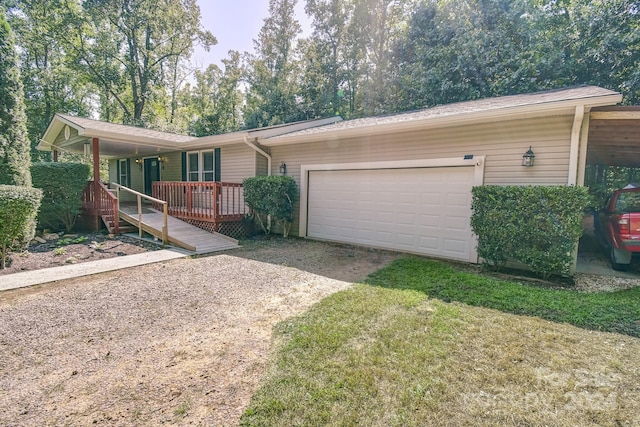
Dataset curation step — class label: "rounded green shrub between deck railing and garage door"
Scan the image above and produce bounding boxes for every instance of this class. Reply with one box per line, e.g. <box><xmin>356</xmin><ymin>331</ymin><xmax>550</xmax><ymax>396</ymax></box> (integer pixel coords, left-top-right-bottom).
<box><xmin>243</xmin><ymin>176</ymin><xmax>298</xmax><ymax>237</ymax></box>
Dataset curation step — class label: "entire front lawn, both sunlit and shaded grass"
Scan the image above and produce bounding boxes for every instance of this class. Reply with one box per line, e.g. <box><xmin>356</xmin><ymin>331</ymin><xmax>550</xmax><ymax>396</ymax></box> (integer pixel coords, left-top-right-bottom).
<box><xmin>241</xmin><ymin>258</ymin><xmax>640</xmax><ymax>426</ymax></box>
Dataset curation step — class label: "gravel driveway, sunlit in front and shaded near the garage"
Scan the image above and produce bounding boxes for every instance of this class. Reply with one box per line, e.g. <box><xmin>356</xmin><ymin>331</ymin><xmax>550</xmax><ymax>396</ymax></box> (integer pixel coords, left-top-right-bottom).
<box><xmin>0</xmin><ymin>239</ymin><xmax>397</xmax><ymax>426</ymax></box>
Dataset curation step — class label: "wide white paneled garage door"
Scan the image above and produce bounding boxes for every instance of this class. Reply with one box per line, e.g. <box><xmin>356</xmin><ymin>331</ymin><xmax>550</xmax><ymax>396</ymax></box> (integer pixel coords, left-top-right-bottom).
<box><xmin>307</xmin><ymin>167</ymin><xmax>475</xmax><ymax>261</ymax></box>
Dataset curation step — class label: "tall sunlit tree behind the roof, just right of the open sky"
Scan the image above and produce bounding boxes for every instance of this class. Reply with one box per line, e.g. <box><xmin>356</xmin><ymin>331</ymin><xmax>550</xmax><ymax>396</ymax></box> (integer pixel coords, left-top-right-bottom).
<box><xmin>244</xmin><ymin>0</ymin><xmax>303</xmax><ymax>128</ymax></box>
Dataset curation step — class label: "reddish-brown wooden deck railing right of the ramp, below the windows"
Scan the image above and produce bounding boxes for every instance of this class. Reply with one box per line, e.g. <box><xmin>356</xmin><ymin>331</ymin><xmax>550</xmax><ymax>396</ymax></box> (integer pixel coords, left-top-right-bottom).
<box><xmin>153</xmin><ymin>181</ymin><xmax>248</xmax><ymax>223</ymax></box>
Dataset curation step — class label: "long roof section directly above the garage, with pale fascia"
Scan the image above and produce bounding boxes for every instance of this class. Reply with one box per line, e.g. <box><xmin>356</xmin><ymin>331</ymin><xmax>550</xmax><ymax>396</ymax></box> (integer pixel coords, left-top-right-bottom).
<box><xmin>260</xmin><ymin>86</ymin><xmax>622</xmax><ymax>146</ymax></box>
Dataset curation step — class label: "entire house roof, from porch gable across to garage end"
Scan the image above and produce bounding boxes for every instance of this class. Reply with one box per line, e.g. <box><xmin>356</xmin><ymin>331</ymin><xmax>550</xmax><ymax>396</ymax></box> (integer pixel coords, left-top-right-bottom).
<box><xmin>38</xmin><ymin>86</ymin><xmax>622</xmax><ymax>158</ymax></box>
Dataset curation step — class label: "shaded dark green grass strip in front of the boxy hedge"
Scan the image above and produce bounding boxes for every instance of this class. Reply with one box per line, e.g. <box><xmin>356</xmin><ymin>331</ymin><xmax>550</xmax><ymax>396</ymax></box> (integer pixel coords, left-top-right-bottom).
<box><xmin>366</xmin><ymin>258</ymin><xmax>640</xmax><ymax>337</ymax></box>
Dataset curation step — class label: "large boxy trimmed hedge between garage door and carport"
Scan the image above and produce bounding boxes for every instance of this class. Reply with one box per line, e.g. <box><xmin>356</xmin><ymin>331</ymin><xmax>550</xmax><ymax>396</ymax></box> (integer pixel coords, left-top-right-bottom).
<box><xmin>471</xmin><ymin>186</ymin><xmax>591</xmax><ymax>276</ymax></box>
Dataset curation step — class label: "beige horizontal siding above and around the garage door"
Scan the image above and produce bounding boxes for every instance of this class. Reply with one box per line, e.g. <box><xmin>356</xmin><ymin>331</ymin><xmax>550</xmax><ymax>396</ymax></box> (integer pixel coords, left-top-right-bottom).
<box><xmin>271</xmin><ymin>116</ymin><xmax>573</xmax><ymax>234</ymax></box>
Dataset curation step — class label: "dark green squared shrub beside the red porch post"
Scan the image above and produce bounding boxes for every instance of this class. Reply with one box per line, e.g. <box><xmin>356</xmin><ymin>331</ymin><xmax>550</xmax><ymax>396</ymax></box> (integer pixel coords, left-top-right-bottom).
<box><xmin>31</xmin><ymin>162</ymin><xmax>89</xmax><ymax>231</ymax></box>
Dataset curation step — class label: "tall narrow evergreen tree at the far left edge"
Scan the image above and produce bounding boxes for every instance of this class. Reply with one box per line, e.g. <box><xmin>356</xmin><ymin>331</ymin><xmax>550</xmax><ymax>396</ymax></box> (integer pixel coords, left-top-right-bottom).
<box><xmin>0</xmin><ymin>10</ymin><xmax>31</xmax><ymax>187</ymax></box>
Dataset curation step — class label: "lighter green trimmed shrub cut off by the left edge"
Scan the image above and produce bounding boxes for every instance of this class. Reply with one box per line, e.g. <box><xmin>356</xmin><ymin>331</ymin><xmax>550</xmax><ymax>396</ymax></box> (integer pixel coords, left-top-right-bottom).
<box><xmin>0</xmin><ymin>185</ymin><xmax>42</xmax><ymax>269</ymax></box>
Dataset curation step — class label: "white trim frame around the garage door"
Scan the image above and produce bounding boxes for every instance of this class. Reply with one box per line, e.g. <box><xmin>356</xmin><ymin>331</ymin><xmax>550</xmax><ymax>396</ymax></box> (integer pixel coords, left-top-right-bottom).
<box><xmin>298</xmin><ymin>156</ymin><xmax>485</xmax><ymax>263</ymax></box>
